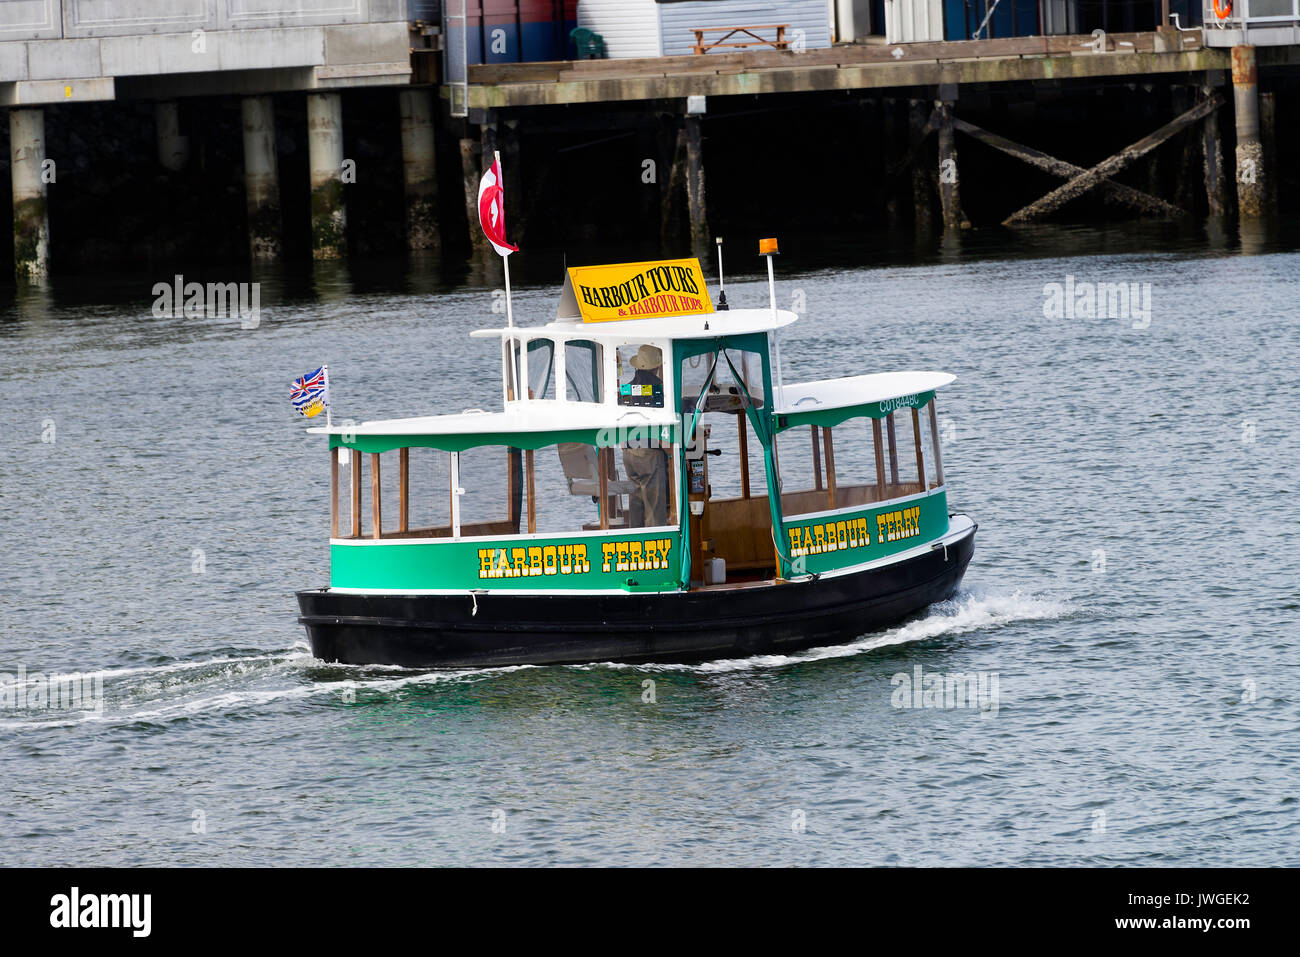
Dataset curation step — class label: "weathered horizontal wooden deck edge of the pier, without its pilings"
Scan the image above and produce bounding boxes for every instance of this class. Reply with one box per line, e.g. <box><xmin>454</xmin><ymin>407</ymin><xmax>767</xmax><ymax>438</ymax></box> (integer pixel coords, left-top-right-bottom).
<box><xmin>457</xmin><ymin>31</ymin><xmax>1230</xmax><ymax>108</ymax></box>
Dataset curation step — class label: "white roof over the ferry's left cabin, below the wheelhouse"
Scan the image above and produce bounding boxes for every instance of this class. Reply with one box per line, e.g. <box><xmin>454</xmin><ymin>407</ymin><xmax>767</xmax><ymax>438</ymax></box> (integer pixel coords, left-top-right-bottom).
<box><xmin>307</xmin><ymin>399</ymin><xmax>677</xmax><ymax>436</ymax></box>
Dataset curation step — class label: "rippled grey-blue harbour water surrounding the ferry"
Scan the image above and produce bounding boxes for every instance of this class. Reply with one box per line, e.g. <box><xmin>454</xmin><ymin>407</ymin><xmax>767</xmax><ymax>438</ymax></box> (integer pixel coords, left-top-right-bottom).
<box><xmin>0</xmin><ymin>230</ymin><xmax>1300</xmax><ymax>865</ymax></box>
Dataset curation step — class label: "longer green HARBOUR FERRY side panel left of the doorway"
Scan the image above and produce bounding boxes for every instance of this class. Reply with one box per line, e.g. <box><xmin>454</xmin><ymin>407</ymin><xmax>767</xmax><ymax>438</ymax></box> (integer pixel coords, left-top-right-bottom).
<box><xmin>330</xmin><ymin>529</ymin><xmax>681</xmax><ymax>592</ymax></box>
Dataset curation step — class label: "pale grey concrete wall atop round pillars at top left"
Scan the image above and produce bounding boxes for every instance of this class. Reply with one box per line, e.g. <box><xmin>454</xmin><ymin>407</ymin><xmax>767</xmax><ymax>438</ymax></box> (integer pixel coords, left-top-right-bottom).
<box><xmin>0</xmin><ymin>0</ymin><xmax>411</xmax><ymax>105</ymax></box>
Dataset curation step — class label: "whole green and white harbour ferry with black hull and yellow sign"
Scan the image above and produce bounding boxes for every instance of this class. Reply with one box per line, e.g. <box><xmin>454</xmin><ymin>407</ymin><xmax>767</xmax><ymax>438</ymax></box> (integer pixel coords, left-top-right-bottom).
<box><xmin>298</xmin><ymin>248</ymin><xmax>976</xmax><ymax>667</ymax></box>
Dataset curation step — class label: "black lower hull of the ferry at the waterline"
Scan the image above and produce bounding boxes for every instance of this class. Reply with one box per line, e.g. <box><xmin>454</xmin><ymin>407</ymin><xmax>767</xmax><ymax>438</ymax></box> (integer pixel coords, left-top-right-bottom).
<box><xmin>298</xmin><ymin>525</ymin><xmax>975</xmax><ymax>668</ymax></box>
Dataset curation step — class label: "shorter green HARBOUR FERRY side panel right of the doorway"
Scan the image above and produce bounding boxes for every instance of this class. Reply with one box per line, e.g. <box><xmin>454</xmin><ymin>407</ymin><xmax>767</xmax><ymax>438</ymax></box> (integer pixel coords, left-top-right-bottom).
<box><xmin>781</xmin><ymin>489</ymin><xmax>948</xmax><ymax>575</ymax></box>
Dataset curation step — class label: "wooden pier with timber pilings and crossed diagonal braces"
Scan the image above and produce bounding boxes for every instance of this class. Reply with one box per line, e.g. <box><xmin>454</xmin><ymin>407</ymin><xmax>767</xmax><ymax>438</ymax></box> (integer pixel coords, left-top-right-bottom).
<box><xmin>443</xmin><ymin>29</ymin><xmax>1300</xmax><ymax>255</ymax></box>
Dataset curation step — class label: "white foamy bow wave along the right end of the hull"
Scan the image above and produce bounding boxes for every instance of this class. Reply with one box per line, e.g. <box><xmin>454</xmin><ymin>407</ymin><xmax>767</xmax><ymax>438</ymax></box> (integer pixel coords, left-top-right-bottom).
<box><xmin>576</xmin><ymin>589</ymin><xmax>1075</xmax><ymax>674</ymax></box>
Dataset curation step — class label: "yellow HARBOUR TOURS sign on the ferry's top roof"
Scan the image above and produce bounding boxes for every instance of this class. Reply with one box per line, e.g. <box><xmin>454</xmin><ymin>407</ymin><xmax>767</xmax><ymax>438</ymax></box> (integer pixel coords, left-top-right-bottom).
<box><xmin>555</xmin><ymin>259</ymin><xmax>714</xmax><ymax>322</ymax></box>
